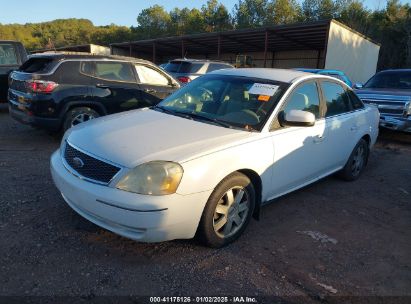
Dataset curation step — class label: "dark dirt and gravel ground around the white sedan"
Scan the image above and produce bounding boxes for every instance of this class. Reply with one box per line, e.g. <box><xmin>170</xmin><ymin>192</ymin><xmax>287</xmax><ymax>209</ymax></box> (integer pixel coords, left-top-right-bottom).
<box><xmin>0</xmin><ymin>105</ymin><xmax>411</xmax><ymax>303</ymax></box>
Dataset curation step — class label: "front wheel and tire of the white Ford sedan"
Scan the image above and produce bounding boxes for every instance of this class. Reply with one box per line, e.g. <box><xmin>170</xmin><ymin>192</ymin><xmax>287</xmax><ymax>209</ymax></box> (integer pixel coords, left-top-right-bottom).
<box><xmin>198</xmin><ymin>173</ymin><xmax>256</xmax><ymax>248</ymax></box>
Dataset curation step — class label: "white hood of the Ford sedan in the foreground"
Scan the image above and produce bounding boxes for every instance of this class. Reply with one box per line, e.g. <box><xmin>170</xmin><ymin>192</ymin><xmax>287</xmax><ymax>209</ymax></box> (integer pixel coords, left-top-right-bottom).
<box><xmin>66</xmin><ymin>109</ymin><xmax>256</xmax><ymax>168</ymax></box>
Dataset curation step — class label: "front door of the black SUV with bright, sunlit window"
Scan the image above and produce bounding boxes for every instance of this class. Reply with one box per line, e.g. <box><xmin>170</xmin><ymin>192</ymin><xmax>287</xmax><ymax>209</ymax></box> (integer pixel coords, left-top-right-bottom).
<box><xmin>134</xmin><ymin>64</ymin><xmax>177</xmax><ymax>106</ymax></box>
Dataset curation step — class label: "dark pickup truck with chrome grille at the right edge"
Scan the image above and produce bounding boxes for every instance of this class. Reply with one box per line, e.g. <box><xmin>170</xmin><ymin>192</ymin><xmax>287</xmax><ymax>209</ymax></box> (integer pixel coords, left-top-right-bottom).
<box><xmin>354</xmin><ymin>69</ymin><xmax>411</xmax><ymax>132</ymax></box>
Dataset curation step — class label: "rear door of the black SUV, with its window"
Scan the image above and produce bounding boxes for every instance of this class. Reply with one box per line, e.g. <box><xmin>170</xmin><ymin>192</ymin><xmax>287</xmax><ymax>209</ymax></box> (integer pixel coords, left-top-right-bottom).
<box><xmin>84</xmin><ymin>60</ymin><xmax>146</xmax><ymax>114</ymax></box>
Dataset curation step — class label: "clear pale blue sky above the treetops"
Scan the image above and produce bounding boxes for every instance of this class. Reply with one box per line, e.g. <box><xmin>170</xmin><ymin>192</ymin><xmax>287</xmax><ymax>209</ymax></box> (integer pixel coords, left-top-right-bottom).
<box><xmin>0</xmin><ymin>0</ymin><xmax>411</xmax><ymax>26</ymax></box>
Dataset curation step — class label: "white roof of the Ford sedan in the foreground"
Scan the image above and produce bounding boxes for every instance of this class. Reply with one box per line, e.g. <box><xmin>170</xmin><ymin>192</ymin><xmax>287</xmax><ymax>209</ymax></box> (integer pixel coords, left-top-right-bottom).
<box><xmin>211</xmin><ymin>68</ymin><xmax>314</xmax><ymax>83</ymax></box>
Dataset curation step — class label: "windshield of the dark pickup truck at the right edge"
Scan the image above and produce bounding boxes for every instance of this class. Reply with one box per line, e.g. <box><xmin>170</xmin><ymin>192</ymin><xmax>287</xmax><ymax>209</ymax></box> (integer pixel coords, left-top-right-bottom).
<box><xmin>364</xmin><ymin>71</ymin><xmax>411</xmax><ymax>90</ymax></box>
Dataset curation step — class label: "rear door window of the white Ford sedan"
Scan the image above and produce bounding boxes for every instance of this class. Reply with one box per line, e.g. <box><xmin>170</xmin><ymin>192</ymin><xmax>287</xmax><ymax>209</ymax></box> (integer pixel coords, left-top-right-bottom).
<box><xmin>321</xmin><ymin>81</ymin><xmax>351</xmax><ymax>117</ymax></box>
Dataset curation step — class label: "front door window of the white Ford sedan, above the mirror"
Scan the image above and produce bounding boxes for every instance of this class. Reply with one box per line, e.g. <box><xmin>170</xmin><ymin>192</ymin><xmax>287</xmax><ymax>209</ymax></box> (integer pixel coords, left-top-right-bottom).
<box><xmin>283</xmin><ymin>82</ymin><xmax>320</xmax><ymax>119</ymax></box>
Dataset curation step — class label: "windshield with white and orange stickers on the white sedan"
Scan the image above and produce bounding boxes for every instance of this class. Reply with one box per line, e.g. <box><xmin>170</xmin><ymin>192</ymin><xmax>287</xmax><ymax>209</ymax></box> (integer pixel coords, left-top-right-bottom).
<box><xmin>158</xmin><ymin>75</ymin><xmax>288</xmax><ymax>130</ymax></box>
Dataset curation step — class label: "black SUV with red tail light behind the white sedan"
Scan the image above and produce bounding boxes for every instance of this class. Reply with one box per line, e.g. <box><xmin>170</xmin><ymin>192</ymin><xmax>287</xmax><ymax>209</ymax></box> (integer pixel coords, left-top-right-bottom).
<box><xmin>8</xmin><ymin>53</ymin><xmax>180</xmax><ymax>131</ymax></box>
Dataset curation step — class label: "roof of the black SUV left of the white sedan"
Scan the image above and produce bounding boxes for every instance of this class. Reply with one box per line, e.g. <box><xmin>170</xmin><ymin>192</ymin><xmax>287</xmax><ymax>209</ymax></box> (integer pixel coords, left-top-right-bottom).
<box><xmin>30</xmin><ymin>51</ymin><xmax>153</xmax><ymax>64</ymax></box>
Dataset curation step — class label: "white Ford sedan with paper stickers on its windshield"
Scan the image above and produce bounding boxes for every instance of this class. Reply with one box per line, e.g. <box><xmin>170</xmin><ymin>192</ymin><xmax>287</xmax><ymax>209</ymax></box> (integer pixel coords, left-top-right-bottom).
<box><xmin>51</xmin><ymin>69</ymin><xmax>379</xmax><ymax>247</ymax></box>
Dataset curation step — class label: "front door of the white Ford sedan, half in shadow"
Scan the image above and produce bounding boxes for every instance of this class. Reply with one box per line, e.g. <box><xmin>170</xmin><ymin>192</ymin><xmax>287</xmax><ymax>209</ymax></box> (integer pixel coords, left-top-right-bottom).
<box><xmin>270</xmin><ymin>81</ymin><xmax>330</xmax><ymax>198</ymax></box>
